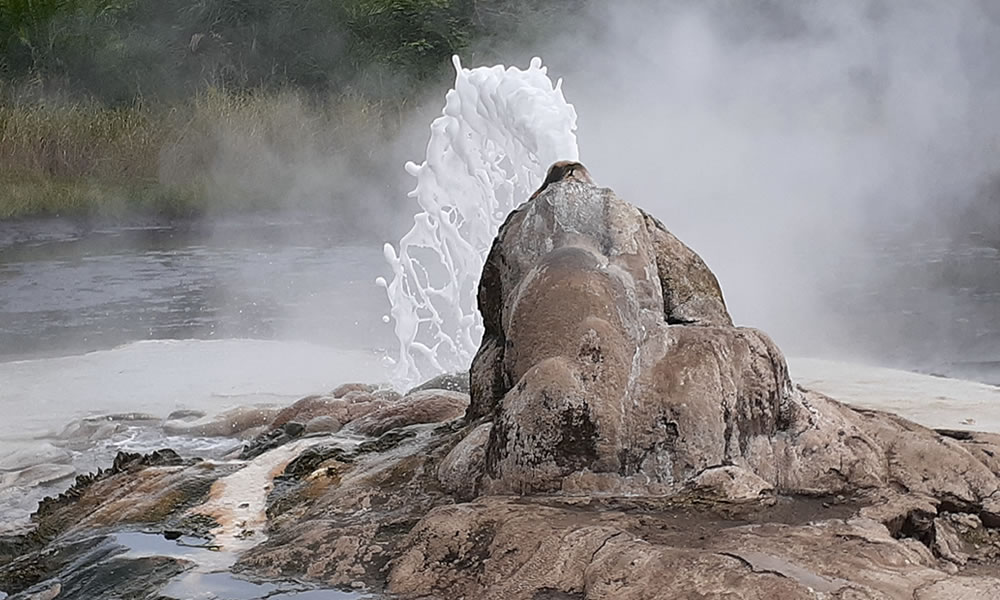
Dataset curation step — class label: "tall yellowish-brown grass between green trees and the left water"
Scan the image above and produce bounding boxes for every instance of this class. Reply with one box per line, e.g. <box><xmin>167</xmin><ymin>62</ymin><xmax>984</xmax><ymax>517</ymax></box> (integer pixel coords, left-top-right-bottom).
<box><xmin>0</xmin><ymin>89</ymin><xmax>402</xmax><ymax>219</ymax></box>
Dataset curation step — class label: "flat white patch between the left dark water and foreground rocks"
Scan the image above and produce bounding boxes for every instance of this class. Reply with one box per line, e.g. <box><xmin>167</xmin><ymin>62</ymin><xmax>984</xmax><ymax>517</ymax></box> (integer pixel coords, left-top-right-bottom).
<box><xmin>0</xmin><ymin>340</ymin><xmax>386</xmax><ymax>440</ymax></box>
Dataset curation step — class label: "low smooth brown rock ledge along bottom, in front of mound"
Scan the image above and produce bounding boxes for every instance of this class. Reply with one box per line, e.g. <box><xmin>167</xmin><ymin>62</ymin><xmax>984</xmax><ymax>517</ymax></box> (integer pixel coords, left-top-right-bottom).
<box><xmin>388</xmin><ymin>498</ymin><xmax>972</xmax><ymax>600</ymax></box>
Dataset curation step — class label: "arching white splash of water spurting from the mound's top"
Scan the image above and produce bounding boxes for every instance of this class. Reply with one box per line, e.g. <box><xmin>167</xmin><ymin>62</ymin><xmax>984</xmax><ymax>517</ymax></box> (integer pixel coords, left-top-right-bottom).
<box><xmin>376</xmin><ymin>56</ymin><xmax>579</xmax><ymax>387</ymax></box>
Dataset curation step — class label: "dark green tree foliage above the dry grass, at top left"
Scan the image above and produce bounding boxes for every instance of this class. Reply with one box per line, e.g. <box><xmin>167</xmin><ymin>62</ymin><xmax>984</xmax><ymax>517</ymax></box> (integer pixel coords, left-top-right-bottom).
<box><xmin>0</xmin><ymin>0</ymin><xmax>571</xmax><ymax>104</ymax></box>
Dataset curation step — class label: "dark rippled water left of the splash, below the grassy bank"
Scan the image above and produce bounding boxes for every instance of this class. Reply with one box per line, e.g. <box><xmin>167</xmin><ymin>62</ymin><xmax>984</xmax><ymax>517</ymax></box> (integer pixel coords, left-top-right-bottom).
<box><xmin>0</xmin><ymin>217</ymin><xmax>392</xmax><ymax>360</ymax></box>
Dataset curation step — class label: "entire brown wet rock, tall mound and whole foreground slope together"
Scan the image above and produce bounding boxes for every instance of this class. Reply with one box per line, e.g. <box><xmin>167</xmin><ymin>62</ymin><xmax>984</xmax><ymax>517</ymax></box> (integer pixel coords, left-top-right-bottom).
<box><xmin>0</xmin><ymin>176</ymin><xmax>1000</xmax><ymax>600</ymax></box>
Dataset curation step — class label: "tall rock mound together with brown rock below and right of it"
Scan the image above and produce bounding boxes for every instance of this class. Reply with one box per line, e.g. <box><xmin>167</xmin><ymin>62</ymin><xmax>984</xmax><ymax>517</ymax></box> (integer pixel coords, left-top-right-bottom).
<box><xmin>412</xmin><ymin>171</ymin><xmax>1000</xmax><ymax>598</ymax></box>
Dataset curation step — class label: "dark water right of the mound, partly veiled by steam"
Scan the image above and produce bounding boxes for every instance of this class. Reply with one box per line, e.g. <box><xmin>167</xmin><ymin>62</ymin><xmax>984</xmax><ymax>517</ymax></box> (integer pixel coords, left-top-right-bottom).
<box><xmin>825</xmin><ymin>235</ymin><xmax>1000</xmax><ymax>385</ymax></box>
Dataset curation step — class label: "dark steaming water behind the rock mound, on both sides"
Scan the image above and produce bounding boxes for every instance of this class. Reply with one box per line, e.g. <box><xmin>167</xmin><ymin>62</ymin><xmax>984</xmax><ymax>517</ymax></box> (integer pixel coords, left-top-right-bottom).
<box><xmin>0</xmin><ymin>216</ymin><xmax>1000</xmax><ymax>383</ymax></box>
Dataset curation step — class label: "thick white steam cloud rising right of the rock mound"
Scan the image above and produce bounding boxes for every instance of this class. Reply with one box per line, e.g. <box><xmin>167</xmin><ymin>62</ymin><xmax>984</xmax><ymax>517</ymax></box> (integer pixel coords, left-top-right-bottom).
<box><xmin>474</xmin><ymin>1</ymin><xmax>1000</xmax><ymax>368</ymax></box>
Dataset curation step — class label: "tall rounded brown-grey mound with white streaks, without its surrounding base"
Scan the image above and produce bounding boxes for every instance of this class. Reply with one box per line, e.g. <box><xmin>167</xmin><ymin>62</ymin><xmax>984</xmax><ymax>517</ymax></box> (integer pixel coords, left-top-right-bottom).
<box><xmin>467</xmin><ymin>181</ymin><xmax>885</xmax><ymax>495</ymax></box>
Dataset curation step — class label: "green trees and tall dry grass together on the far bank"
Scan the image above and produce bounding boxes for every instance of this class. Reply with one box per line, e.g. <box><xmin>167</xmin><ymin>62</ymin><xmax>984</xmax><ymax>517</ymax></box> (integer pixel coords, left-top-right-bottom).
<box><xmin>0</xmin><ymin>0</ymin><xmax>574</xmax><ymax>219</ymax></box>
